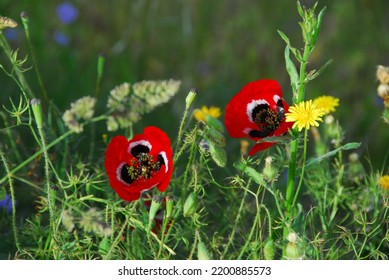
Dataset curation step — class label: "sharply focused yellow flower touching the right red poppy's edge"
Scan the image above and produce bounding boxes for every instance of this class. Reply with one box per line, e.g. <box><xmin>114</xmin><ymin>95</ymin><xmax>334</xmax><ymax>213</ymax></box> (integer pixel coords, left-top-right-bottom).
<box><xmin>285</xmin><ymin>100</ymin><xmax>324</xmax><ymax>131</ymax></box>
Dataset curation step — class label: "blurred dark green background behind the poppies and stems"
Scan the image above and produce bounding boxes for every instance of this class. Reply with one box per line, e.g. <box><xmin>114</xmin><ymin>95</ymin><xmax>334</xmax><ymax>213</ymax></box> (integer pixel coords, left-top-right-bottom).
<box><xmin>0</xmin><ymin>0</ymin><xmax>389</xmax><ymax>169</ymax></box>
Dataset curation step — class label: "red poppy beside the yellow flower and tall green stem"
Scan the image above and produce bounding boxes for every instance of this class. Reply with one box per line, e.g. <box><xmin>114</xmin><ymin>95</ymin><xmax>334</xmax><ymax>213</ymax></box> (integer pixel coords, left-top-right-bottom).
<box><xmin>224</xmin><ymin>80</ymin><xmax>293</xmax><ymax>156</ymax></box>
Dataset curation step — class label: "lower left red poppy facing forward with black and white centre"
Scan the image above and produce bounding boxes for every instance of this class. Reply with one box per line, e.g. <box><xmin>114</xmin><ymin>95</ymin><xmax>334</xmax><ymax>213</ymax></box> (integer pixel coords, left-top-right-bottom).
<box><xmin>104</xmin><ymin>126</ymin><xmax>173</xmax><ymax>201</ymax></box>
